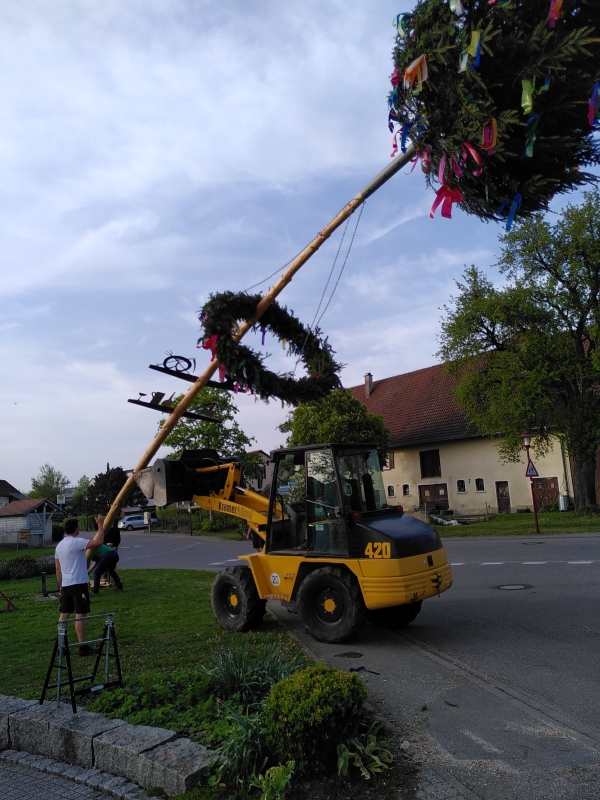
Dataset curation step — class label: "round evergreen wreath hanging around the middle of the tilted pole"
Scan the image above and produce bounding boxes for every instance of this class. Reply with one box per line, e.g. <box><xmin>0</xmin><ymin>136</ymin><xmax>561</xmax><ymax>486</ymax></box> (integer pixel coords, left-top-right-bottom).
<box><xmin>198</xmin><ymin>292</ymin><xmax>342</xmax><ymax>405</ymax></box>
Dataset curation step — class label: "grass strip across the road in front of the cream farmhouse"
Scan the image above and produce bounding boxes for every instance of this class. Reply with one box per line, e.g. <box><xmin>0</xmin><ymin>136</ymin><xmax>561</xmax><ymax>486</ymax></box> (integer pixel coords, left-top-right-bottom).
<box><xmin>434</xmin><ymin>511</ymin><xmax>600</xmax><ymax>538</ymax></box>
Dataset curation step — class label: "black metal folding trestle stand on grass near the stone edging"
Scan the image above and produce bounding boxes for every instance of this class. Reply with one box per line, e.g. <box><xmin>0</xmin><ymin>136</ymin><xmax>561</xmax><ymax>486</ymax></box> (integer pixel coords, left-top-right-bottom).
<box><xmin>40</xmin><ymin>611</ymin><xmax>123</xmax><ymax>714</ymax></box>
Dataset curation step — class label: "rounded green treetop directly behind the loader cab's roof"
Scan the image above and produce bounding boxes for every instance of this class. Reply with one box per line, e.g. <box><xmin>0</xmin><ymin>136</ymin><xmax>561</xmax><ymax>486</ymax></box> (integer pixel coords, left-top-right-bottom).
<box><xmin>279</xmin><ymin>389</ymin><xmax>389</xmax><ymax>463</ymax></box>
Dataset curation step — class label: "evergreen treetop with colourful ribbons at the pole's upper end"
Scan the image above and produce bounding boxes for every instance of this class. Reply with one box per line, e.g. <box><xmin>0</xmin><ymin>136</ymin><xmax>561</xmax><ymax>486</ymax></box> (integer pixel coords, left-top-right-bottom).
<box><xmin>389</xmin><ymin>0</ymin><xmax>600</xmax><ymax>226</ymax></box>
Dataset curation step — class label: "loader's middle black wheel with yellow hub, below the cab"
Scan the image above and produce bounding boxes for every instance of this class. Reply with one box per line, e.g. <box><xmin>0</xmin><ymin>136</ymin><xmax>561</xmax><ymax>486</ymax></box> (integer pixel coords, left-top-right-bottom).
<box><xmin>297</xmin><ymin>567</ymin><xmax>367</xmax><ymax>643</ymax></box>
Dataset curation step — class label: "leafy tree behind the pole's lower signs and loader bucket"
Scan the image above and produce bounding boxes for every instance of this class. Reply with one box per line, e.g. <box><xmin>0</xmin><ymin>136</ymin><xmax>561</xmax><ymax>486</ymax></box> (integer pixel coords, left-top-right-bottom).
<box><xmin>159</xmin><ymin>386</ymin><xmax>258</xmax><ymax>484</ymax></box>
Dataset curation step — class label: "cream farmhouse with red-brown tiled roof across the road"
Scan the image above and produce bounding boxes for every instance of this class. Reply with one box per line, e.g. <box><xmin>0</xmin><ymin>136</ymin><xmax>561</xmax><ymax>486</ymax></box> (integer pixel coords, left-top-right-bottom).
<box><xmin>349</xmin><ymin>364</ymin><xmax>574</xmax><ymax>515</ymax></box>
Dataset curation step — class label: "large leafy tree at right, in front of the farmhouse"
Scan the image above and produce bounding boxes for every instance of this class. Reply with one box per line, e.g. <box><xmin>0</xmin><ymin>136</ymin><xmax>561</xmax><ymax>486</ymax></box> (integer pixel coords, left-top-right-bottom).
<box><xmin>439</xmin><ymin>190</ymin><xmax>600</xmax><ymax>508</ymax></box>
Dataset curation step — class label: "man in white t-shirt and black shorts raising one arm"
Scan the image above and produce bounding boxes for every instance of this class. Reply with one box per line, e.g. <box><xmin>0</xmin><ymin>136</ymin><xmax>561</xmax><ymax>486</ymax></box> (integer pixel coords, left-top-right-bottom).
<box><xmin>55</xmin><ymin>517</ymin><xmax>104</xmax><ymax>656</ymax></box>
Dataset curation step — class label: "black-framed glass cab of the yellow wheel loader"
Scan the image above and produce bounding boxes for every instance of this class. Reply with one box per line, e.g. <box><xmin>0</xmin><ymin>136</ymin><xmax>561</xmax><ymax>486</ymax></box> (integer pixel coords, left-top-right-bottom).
<box><xmin>266</xmin><ymin>444</ymin><xmax>387</xmax><ymax>558</ymax></box>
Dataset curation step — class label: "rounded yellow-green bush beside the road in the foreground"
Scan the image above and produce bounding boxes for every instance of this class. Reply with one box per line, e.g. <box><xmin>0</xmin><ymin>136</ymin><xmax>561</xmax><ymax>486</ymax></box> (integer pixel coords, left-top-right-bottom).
<box><xmin>265</xmin><ymin>664</ymin><xmax>367</xmax><ymax>774</ymax></box>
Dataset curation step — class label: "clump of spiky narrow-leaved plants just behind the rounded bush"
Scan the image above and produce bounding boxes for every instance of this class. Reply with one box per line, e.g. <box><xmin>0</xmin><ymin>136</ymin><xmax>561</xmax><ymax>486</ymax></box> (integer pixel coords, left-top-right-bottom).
<box><xmin>201</xmin><ymin>636</ymin><xmax>307</xmax><ymax>705</ymax></box>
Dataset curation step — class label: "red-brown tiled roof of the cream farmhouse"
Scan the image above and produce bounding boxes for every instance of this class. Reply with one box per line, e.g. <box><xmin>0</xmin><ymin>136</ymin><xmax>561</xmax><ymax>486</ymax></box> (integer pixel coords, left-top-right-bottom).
<box><xmin>349</xmin><ymin>364</ymin><xmax>483</xmax><ymax>447</ymax></box>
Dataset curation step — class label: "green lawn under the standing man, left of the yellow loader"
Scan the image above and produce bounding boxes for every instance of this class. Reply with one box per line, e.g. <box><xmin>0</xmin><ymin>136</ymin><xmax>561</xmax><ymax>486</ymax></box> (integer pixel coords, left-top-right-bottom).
<box><xmin>0</xmin><ymin>569</ymin><xmax>292</xmax><ymax>698</ymax></box>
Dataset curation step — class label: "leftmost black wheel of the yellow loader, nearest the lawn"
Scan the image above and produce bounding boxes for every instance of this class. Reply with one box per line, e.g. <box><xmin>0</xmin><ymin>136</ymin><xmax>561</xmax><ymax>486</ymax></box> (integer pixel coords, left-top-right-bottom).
<box><xmin>210</xmin><ymin>567</ymin><xmax>267</xmax><ymax>631</ymax></box>
